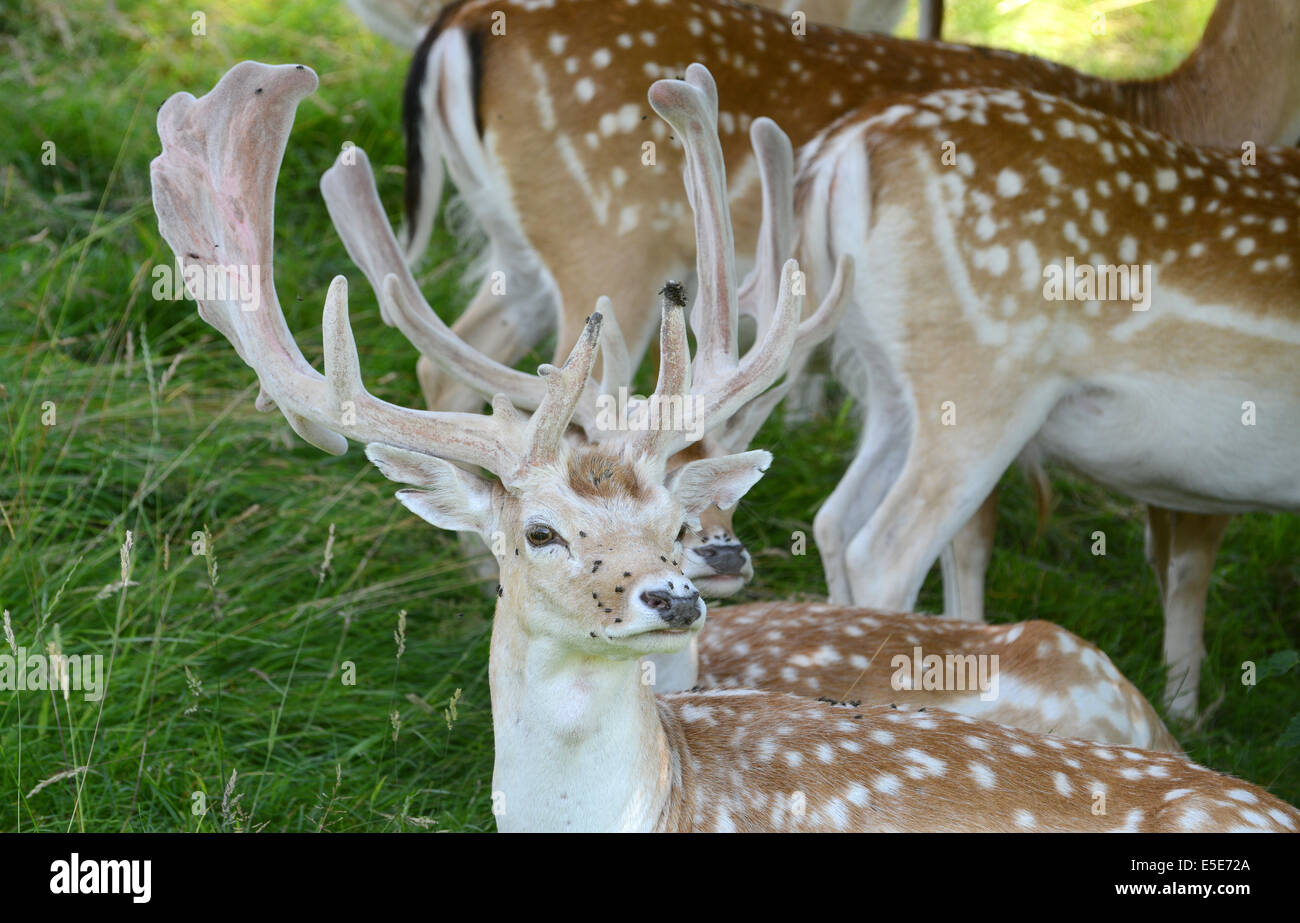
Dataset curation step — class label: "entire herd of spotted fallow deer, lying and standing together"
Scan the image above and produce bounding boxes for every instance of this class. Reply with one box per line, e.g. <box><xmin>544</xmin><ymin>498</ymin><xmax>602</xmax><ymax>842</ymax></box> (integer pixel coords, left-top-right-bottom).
<box><xmin>152</xmin><ymin>0</ymin><xmax>1300</xmax><ymax>831</ymax></box>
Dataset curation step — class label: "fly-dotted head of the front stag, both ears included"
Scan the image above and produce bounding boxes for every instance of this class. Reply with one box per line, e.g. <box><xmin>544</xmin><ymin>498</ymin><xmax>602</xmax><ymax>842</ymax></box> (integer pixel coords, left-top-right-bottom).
<box><xmin>367</xmin><ymin>304</ymin><xmax>771</xmax><ymax>659</ymax></box>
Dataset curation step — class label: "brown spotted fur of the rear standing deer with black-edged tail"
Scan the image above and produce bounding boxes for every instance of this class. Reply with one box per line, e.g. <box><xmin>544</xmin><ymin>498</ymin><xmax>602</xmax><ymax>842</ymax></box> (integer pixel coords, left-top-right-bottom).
<box><xmin>428</xmin><ymin>0</ymin><xmax>1300</xmax><ymax>371</ymax></box>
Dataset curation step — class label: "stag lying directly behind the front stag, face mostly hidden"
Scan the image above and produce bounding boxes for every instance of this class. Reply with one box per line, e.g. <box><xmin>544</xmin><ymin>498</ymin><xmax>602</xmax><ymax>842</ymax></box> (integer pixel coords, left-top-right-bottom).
<box><xmin>321</xmin><ymin>55</ymin><xmax>1178</xmax><ymax>751</ymax></box>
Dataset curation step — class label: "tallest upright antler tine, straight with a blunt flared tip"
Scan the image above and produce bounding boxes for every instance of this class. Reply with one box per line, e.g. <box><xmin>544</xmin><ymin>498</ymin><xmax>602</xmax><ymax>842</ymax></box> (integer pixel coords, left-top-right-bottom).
<box><xmin>649</xmin><ymin>64</ymin><xmax>738</xmax><ymax>380</ymax></box>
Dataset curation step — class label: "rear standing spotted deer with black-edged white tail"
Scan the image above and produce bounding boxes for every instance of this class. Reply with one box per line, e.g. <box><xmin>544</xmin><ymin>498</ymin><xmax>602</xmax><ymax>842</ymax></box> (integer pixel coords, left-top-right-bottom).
<box><xmin>402</xmin><ymin>0</ymin><xmax>1300</xmax><ymax>650</ymax></box>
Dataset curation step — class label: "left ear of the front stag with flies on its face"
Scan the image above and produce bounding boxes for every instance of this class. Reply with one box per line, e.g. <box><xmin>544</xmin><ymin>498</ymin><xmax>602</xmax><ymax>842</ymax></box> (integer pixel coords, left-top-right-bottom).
<box><xmin>365</xmin><ymin>442</ymin><xmax>493</xmax><ymax>536</ymax></box>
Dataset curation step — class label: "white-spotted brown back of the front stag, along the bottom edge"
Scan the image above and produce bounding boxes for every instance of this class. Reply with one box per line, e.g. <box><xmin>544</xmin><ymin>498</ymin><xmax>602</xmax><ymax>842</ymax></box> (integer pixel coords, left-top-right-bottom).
<box><xmin>659</xmin><ymin>693</ymin><xmax>1300</xmax><ymax>832</ymax></box>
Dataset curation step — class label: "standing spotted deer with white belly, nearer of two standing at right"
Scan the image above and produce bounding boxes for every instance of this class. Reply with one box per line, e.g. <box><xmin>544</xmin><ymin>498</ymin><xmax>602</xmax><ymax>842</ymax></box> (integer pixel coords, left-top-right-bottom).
<box><xmin>797</xmin><ymin>90</ymin><xmax>1300</xmax><ymax>715</ymax></box>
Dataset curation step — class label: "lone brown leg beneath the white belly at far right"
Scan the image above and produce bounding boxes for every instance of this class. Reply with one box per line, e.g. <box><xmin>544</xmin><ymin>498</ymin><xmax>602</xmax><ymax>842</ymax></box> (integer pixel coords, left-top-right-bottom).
<box><xmin>1149</xmin><ymin>510</ymin><xmax>1232</xmax><ymax>720</ymax></box>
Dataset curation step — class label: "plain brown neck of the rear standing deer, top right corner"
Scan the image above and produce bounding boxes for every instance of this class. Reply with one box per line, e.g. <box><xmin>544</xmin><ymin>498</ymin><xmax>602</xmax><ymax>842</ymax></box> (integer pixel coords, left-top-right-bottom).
<box><xmin>1122</xmin><ymin>0</ymin><xmax>1300</xmax><ymax>147</ymax></box>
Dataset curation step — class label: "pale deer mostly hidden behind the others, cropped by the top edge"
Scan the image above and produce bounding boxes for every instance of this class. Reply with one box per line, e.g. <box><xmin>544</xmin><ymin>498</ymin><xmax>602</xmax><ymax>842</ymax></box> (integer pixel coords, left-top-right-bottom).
<box><xmin>346</xmin><ymin>0</ymin><xmax>920</xmax><ymax>51</ymax></box>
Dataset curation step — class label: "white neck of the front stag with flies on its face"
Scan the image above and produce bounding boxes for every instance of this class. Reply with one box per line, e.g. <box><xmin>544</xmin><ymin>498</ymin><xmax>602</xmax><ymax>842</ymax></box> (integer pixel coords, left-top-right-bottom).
<box><xmin>489</xmin><ymin>594</ymin><xmax>676</xmax><ymax>832</ymax></box>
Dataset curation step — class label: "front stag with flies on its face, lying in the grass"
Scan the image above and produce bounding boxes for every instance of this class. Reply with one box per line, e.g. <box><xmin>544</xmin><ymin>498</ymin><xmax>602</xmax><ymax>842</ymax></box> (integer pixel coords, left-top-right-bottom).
<box><xmin>151</xmin><ymin>61</ymin><xmax>1300</xmax><ymax>832</ymax></box>
